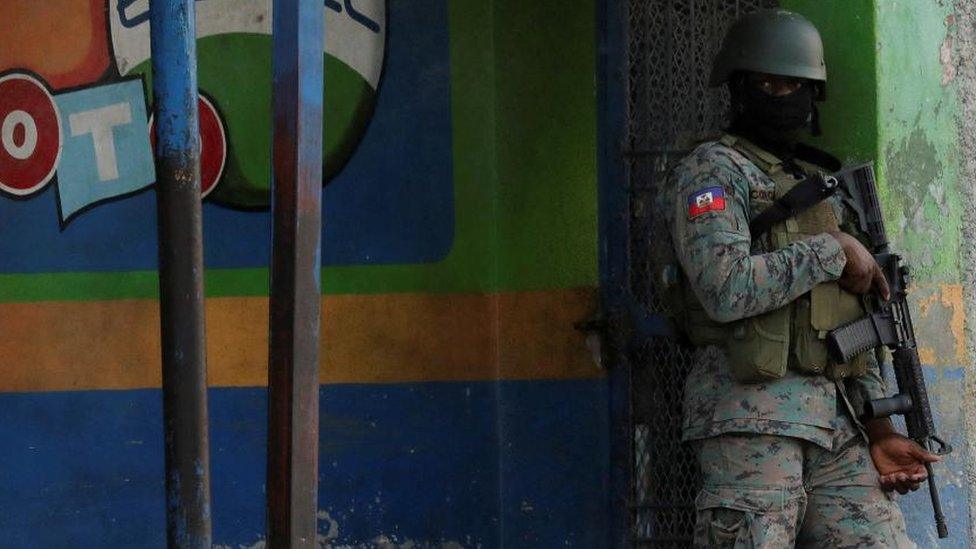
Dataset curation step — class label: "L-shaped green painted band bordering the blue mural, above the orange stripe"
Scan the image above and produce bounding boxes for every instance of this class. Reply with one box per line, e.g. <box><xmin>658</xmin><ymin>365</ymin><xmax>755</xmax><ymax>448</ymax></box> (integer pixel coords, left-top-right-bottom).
<box><xmin>0</xmin><ymin>0</ymin><xmax>597</xmax><ymax>301</ymax></box>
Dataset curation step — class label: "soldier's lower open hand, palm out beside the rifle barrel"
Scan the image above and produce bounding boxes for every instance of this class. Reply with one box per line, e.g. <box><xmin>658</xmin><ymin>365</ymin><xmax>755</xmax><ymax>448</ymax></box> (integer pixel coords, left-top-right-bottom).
<box><xmin>871</xmin><ymin>433</ymin><xmax>940</xmax><ymax>494</ymax></box>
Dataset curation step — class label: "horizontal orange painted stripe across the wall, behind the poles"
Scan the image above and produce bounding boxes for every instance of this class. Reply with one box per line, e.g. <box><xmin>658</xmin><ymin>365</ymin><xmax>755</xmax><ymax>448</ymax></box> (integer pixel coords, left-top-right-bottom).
<box><xmin>0</xmin><ymin>289</ymin><xmax>602</xmax><ymax>392</ymax></box>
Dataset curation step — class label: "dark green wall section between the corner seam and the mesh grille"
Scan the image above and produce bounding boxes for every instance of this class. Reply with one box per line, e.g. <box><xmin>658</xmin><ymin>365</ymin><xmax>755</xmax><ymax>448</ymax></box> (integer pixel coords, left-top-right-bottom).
<box><xmin>494</xmin><ymin>0</ymin><xmax>597</xmax><ymax>290</ymax></box>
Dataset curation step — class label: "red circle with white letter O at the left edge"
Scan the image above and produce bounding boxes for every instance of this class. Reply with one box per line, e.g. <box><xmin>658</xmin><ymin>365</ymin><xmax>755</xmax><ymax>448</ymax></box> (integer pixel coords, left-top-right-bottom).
<box><xmin>0</xmin><ymin>73</ymin><xmax>61</xmax><ymax>196</ymax></box>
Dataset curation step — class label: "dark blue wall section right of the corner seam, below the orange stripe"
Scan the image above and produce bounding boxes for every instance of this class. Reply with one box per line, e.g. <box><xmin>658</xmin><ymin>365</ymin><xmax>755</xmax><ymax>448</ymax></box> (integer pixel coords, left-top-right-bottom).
<box><xmin>498</xmin><ymin>382</ymin><xmax>610</xmax><ymax>548</ymax></box>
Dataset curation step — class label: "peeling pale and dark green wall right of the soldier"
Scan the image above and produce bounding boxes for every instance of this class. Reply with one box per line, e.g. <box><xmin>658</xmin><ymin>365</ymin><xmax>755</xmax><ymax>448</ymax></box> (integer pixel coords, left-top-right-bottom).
<box><xmin>783</xmin><ymin>0</ymin><xmax>976</xmax><ymax>547</ymax></box>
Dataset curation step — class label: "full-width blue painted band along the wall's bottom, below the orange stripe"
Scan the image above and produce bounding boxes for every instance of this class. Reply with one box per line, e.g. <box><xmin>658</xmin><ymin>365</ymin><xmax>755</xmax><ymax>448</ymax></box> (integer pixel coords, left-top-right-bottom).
<box><xmin>0</xmin><ymin>380</ymin><xmax>608</xmax><ymax>547</ymax></box>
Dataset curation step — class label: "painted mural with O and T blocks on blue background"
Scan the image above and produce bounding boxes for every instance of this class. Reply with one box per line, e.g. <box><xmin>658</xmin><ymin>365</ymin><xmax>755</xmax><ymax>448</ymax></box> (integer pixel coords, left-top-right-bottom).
<box><xmin>0</xmin><ymin>0</ymin><xmax>453</xmax><ymax>273</ymax></box>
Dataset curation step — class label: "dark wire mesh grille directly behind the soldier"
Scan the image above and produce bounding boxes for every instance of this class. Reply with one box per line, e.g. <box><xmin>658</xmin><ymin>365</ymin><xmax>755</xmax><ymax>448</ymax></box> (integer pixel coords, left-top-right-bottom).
<box><xmin>626</xmin><ymin>0</ymin><xmax>778</xmax><ymax>547</ymax></box>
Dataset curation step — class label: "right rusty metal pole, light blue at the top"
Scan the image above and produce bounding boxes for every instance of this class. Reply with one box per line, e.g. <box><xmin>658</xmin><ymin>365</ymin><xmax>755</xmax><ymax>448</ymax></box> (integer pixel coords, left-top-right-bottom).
<box><xmin>267</xmin><ymin>0</ymin><xmax>325</xmax><ymax>548</ymax></box>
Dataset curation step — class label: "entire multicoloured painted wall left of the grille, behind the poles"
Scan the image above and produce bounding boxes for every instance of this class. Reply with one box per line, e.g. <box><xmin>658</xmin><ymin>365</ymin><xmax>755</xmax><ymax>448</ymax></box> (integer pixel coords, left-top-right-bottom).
<box><xmin>0</xmin><ymin>0</ymin><xmax>609</xmax><ymax>547</ymax></box>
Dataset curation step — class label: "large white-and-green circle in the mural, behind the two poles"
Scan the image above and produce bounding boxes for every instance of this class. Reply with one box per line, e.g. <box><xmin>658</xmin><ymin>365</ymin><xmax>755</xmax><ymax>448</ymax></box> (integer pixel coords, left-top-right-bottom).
<box><xmin>110</xmin><ymin>0</ymin><xmax>387</xmax><ymax>208</ymax></box>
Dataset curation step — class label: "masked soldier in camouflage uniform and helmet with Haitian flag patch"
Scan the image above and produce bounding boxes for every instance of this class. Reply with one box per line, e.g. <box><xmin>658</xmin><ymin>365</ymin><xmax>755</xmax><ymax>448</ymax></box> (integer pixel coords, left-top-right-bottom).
<box><xmin>664</xmin><ymin>11</ymin><xmax>939</xmax><ymax>547</ymax></box>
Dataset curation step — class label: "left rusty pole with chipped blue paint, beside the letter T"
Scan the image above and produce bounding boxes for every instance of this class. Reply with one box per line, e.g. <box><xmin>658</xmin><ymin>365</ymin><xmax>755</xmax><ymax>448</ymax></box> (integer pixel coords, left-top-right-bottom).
<box><xmin>150</xmin><ymin>0</ymin><xmax>211</xmax><ymax>548</ymax></box>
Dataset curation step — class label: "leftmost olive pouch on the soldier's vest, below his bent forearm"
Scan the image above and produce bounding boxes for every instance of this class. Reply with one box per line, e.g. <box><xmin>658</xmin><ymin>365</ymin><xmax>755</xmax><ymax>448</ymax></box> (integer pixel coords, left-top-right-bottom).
<box><xmin>725</xmin><ymin>305</ymin><xmax>793</xmax><ymax>383</ymax></box>
